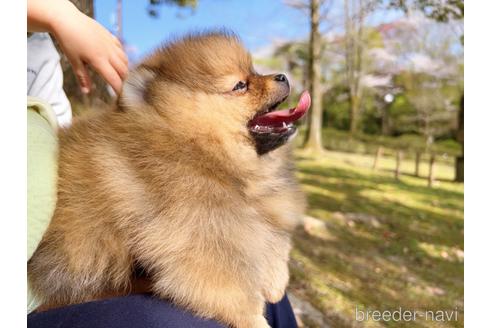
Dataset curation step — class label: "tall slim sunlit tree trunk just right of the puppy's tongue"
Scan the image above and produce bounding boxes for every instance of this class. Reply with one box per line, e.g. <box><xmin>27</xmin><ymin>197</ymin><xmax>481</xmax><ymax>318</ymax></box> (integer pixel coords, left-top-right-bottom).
<box><xmin>304</xmin><ymin>0</ymin><xmax>323</xmax><ymax>152</ymax></box>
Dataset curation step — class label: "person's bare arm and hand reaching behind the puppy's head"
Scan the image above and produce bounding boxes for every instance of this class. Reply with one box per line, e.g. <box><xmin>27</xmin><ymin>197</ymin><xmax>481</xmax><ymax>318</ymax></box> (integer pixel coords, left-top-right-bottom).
<box><xmin>27</xmin><ymin>0</ymin><xmax>128</xmax><ymax>93</ymax></box>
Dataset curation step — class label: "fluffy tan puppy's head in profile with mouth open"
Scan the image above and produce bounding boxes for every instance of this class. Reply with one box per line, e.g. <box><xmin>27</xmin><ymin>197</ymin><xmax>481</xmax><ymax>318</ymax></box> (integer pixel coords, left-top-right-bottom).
<box><xmin>119</xmin><ymin>32</ymin><xmax>311</xmax><ymax>155</ymax></box>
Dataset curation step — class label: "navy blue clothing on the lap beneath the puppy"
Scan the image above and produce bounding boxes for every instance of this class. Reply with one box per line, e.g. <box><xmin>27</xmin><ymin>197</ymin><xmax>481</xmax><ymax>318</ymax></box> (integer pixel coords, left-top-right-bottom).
<box><xmin>27</xmin><ymin>294</ymin><xmax>297</xmax><ymax>328</ymax></box>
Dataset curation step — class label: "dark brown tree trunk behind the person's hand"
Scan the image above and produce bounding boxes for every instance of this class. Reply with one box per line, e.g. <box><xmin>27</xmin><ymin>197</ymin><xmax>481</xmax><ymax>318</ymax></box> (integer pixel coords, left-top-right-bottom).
<box><xmin>52</xmin><ymin>0</ymin><xmax>114</xmax><ymax>110</ymax></box>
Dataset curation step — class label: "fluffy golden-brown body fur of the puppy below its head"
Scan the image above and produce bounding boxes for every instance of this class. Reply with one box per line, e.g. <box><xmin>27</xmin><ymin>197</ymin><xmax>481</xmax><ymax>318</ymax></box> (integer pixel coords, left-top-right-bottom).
<box><xmin>29</xmin><ymin>116</ymin><xmax>304</xmax><ymax>310</ymax></box>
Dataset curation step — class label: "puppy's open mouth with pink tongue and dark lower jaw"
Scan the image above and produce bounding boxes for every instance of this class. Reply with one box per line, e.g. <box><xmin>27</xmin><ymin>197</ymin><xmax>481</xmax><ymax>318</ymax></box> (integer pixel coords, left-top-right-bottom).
<box><xmin>248</xmin><ymin>91</ymin><xmax>311</xmax><ymax>155</ymax></box>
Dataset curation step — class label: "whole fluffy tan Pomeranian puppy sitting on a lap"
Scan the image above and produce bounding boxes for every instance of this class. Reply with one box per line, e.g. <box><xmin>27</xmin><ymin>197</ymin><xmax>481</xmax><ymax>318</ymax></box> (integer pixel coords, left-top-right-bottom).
<box><xmin>28</xmin><ymin>32</ymin><xmax>310</xmax><ymax>328</ymax></box>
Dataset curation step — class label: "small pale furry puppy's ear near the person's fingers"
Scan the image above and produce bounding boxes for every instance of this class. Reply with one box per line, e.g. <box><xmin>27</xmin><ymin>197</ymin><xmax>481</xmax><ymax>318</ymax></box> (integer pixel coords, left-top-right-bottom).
<box><xmin>118</xmin><ymin>67</ymin><xmax>156</xmax><ymax>110</ymax></box>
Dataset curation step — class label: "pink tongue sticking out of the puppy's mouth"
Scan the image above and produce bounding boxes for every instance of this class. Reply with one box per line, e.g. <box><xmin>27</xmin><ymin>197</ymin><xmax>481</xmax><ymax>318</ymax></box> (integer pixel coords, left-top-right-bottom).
<box><xmin>249</xmin><ymin>91</ymin><xmax>311</xmax><ymax>126</ymax></box>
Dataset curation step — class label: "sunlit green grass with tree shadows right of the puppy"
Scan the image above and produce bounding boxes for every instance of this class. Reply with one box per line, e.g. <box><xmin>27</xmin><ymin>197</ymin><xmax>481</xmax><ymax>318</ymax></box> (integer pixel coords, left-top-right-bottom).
<box><xmin>290</xmin><ymin>150</ymin><xmax>464</xmax><ymax>328</ymax></box>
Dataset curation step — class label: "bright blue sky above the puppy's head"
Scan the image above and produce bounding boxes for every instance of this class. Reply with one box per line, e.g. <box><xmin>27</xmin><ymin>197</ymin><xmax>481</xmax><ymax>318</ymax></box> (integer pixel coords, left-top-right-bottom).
<box><xmin>94</xmin><ymin>0</ymin><xmax>402</xmax><ymax>60</ymax></box>
